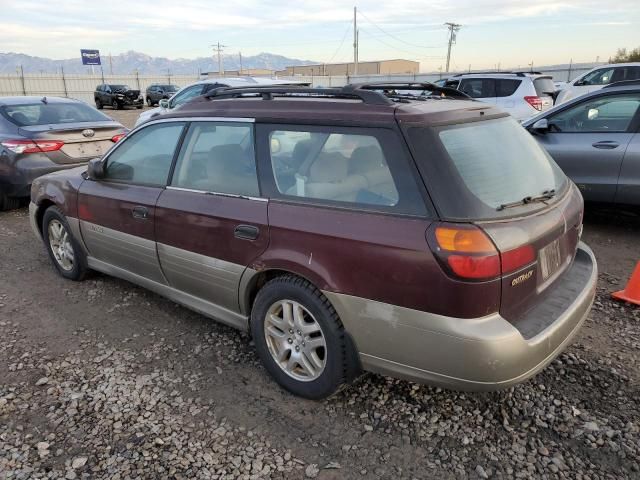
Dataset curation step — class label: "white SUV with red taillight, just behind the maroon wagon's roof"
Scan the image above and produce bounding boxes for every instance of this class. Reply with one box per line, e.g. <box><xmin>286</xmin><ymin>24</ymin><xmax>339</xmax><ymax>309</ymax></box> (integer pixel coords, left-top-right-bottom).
<box><xmin>444</xmin><ymin>72</ymin><xmax>556</xmax><ymax>122</ymax></box>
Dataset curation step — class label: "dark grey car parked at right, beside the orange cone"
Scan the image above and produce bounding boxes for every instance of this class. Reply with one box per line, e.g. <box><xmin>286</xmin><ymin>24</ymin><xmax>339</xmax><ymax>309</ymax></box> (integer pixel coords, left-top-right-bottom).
<box><xmin>523</xmin><ymin>81</ymin><xmax>640</xmax><ymax>207</ymax></box>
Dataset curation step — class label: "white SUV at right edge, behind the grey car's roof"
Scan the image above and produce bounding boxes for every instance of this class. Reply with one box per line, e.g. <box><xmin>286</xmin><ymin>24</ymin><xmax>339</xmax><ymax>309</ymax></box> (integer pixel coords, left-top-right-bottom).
<box><xmin>556</xmin><ymin>62</ymin><xmax>640</xmax><ymax>104</ymax></box>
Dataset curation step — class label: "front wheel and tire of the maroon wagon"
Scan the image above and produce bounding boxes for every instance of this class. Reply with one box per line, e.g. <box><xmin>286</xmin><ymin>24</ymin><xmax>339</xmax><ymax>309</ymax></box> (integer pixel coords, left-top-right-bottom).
<box><xmin>42</xmin><ymin>207</ymin><xmax>88</xmax><ymax>281</ymax></box>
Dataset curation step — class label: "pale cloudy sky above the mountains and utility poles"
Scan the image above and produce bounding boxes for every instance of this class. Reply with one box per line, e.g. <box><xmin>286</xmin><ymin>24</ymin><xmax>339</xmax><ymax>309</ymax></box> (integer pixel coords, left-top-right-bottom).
<box><xmin>0</xmin><ymin>0</ymin><xmax>640</xmax><ymax>71</ymax></box>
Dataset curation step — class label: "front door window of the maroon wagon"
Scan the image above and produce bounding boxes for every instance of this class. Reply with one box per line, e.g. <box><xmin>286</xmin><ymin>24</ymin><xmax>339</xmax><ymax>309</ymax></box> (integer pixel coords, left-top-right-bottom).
<box><xmin>105</xmin><ymin>122</ymin><xmax>185</xmax><ymax>186</ymax></box>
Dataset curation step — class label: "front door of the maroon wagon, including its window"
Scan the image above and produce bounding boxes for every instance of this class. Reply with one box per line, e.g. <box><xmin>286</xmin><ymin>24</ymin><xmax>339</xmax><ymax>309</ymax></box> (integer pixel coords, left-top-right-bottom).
<box><xmin>78</xmin><ymin>122</ymin><xmax>185</xmax><ymax>283</ymax></box>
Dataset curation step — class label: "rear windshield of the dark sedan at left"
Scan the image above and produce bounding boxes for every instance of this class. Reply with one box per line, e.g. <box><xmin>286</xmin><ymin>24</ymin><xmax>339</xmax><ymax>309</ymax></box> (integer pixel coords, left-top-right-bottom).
<box><xmin>0</xmin><ymin>102</ymin><xmax>111</xmax><ymax>127</ymax></box>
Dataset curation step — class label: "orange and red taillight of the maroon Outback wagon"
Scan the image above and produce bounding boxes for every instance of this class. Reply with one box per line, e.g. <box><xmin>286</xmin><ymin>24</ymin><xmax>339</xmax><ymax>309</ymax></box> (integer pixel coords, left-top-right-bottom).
<box><xmin>428</xmin><ymin>224</ymin><xmax>535</xmax><ymax>280</ymax></box>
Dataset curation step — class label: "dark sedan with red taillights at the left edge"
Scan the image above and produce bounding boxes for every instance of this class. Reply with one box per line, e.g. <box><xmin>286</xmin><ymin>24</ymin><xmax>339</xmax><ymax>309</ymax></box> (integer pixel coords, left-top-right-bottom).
<box><xmin>0</xmin><ymin>97</ymin><xmax>127</xmax><ymax>210</ymax></box>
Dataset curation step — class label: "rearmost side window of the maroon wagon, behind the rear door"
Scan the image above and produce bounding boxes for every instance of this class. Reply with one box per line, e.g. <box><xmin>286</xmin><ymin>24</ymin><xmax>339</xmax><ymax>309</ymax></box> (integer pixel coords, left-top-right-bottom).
<box><xmin>270</xmin><ymin>130</ymin><xmax>399</xmax><ymax>206</ymax></box>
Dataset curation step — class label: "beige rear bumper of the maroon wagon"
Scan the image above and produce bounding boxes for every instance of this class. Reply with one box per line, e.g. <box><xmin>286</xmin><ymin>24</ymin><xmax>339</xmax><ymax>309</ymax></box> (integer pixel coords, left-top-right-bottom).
<box><xmin>325</xmin><ymin>243</ymin><xmax>597</xmax><ymax>391</ymax></box>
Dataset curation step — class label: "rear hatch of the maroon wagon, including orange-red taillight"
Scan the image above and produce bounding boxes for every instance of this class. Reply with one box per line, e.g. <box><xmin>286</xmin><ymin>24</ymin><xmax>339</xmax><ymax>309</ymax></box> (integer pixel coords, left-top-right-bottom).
<box><xmin>408</xmin><ymin>117</ymin><xmax>583</xmax><ymax>321</ymax></box>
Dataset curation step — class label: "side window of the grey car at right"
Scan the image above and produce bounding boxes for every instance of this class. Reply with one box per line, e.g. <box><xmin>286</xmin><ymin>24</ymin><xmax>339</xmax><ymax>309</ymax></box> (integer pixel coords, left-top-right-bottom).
<box><xmin>548</xmin><ymin>94</ymin><xmax>640</xmax><ymax>132</ymax></box>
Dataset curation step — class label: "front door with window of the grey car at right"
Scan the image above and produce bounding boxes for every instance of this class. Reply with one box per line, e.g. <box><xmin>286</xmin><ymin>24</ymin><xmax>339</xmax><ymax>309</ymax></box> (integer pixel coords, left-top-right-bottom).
<box><xmin>537</xmin><ymin>92</ymin><xmax>640</xmax><ymax>202</ymax></box>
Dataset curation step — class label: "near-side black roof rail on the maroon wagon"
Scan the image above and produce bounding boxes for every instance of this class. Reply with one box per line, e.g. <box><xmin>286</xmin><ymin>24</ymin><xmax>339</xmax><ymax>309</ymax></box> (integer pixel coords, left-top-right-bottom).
<box><xmin>204</xmin><ymin>85</ymin><xmax>393</xmax><ymax>105</ymax></box>
